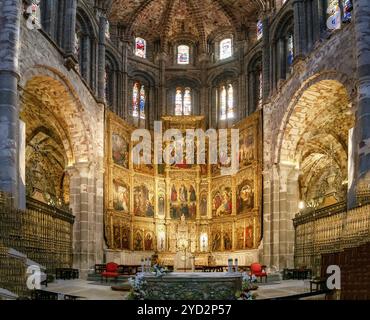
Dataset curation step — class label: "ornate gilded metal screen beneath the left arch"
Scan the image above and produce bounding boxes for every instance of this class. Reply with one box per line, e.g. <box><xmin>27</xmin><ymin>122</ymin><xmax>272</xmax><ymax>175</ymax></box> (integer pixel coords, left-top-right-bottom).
<box><xmin>0</xmin><ymin>194</ymin><xmax>74</xmax><ymax>295</ymax></box>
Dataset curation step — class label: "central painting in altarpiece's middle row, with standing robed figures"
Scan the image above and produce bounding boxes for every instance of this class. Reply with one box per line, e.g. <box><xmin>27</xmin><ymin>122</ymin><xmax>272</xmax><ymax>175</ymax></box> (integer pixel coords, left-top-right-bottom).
<box><xmin>170</xmin><ymin>183</ymin><xmax>197</xmax><ymax>220</ymax></box>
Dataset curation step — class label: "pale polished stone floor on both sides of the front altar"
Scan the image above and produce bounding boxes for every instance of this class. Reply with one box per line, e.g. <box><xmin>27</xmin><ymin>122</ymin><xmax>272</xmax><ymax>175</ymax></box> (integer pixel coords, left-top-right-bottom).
<box><xmin>46</xmin><ymin>280</ymin><xmax>324</xmax><ymax>300</ymax></box>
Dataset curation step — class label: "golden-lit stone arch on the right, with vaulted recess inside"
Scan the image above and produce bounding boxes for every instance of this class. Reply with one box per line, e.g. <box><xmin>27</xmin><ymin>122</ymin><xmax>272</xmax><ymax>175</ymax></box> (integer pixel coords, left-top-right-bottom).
<box><xmin>276</xmin><ymin>76</ymin><xmax>354</xmax><ymax>208</ymax></box>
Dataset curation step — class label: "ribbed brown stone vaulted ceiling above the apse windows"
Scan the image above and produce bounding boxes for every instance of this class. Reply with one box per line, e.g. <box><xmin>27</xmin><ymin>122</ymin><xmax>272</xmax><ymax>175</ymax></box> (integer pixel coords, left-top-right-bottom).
<box><xmin>109</xmin><ymin>0</ymin><xmax>269</xmax><ymax>43</ymax></box>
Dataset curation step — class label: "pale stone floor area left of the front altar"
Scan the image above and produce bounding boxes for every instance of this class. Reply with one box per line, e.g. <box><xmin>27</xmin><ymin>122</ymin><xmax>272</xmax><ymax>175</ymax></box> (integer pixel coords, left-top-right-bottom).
<box><xmin>45</xmin><ymin>279</ymin><xmax>128</xmax><ymax>300</ymax></box>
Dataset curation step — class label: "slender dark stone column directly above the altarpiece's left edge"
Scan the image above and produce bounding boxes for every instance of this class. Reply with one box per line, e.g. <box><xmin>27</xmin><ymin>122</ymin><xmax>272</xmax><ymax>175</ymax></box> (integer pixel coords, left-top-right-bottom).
<box><xmin>98</xmin><ymin>14</ymin><xmax>107</xmax><ymax>103</ymax></box>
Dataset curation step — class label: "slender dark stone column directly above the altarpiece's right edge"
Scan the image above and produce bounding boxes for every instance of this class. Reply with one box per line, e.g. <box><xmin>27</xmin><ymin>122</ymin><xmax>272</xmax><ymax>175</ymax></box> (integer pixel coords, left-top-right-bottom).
<box><xmin>262</xmin><ymin>18</ymin><xmax>270</xmax><ymax>102</ymax></box>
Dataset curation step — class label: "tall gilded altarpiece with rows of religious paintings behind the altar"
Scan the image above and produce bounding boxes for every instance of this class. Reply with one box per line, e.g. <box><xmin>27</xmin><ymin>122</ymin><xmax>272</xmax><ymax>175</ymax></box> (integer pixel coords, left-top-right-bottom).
<box><xmin>105</xmin><ymin>113</ymin><xmax>262</xmax><ymax>268</ymax></box>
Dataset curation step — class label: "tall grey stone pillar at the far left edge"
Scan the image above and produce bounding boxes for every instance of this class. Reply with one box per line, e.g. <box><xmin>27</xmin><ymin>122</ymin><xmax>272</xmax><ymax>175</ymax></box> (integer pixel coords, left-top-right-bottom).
<box><xmin>0</xmin><ymin>0</ymin><xmax>21</xmax><ymax>203</ymax></box>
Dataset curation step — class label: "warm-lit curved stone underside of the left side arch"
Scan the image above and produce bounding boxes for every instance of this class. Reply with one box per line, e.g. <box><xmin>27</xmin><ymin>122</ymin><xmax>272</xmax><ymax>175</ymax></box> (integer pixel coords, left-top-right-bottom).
<box><xmin>19</xmin><ymin>65</ymin><xmax>94</xmax><ymax>165</ymax></box>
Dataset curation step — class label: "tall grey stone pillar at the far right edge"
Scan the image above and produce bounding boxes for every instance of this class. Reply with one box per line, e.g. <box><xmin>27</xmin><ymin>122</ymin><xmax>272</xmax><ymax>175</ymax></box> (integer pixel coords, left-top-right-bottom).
<box><xmin>353</xmin><ymin>0</ymin><xmax>370</xmax><ymax>196</ymax></box>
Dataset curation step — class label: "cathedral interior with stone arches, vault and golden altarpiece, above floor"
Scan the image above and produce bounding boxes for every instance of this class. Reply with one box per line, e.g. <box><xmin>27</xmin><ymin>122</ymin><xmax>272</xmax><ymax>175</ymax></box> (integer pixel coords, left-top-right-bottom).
<box><xmin>0</xmin><ymin>0</ymin><xmax>370</xmax><ymax>300</ymax></box>
